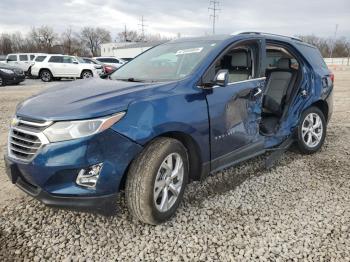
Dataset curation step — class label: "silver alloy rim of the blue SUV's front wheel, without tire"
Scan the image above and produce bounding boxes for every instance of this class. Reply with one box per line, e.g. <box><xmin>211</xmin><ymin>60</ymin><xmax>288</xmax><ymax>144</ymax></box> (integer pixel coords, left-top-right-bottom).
<box><xmin>153</xmin><ymin>153</ymin><xmax>184</xmax><ymax>212</ymax></box>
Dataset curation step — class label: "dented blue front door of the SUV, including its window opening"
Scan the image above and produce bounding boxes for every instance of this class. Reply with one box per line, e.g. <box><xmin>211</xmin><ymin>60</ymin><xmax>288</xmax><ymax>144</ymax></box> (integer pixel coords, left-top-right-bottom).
<box><xmin>207</xmin><ymin>40</ymin><xmax>265</xmax><ymax>170</ymax></box>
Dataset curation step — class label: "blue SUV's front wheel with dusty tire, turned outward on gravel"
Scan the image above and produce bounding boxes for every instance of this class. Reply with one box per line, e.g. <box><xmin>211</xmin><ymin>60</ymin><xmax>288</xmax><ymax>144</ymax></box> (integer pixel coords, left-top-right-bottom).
<box><xmin>125</xmin><ymin>138</ymin><xmax>189</xmax><ymax>225</ymax></box>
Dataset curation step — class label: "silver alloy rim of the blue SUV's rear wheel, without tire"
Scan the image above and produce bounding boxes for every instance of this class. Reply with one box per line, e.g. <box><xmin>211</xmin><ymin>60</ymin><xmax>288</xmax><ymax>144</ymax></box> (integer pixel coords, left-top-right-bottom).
<box><xmin>301</xmin><ymin>113</ymin><xmax>323</xmax><ymax>148</ymax></box>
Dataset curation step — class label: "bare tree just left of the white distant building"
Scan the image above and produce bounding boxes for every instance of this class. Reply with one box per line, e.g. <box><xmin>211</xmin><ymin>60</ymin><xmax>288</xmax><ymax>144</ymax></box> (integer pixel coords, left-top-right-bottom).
<box><xmin>80</xmin><ymin>27</ymin><xmax>111</xmax><ymax>56</ymax></box>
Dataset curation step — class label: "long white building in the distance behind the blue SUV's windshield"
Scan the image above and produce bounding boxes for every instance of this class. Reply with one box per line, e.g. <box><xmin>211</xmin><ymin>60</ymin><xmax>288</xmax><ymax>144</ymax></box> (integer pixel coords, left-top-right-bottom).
<box><xmin>101</xmin><ymin>41</ymin><xmax>167</xmax><ymax>58</ymax></box>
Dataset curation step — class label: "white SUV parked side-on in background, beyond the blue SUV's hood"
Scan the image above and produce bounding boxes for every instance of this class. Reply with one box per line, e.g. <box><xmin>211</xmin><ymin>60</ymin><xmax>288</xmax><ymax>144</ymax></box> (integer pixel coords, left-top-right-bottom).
<box><xmin>31</xmin><ymin>55</ymin><xmax>99</xmax><ymax>82</ymax></box>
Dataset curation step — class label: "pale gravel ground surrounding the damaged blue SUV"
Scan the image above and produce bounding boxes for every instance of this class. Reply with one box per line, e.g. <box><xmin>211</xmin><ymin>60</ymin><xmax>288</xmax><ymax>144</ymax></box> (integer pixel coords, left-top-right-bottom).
<box><xmin>0</xmin><ymin>71</ymin><xmax>350</xmax><ymax>261</ymax></box>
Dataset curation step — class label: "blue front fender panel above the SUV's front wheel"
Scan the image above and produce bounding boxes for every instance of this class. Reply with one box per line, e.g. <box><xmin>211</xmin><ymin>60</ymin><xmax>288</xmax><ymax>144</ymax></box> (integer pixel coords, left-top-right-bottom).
<box><xmin>112</xmin><ymin>90</ymin><xmax>210</xmax><ymax>161</ymax></box>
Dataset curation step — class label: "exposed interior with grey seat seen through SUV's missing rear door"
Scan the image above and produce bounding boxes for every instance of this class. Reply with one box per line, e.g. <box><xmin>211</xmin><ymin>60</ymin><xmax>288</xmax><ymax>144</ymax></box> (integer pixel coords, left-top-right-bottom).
<box><xmin>260</xmin><ymin>45</ymin><xmax>301</xmax><ymax>134</ymax></box>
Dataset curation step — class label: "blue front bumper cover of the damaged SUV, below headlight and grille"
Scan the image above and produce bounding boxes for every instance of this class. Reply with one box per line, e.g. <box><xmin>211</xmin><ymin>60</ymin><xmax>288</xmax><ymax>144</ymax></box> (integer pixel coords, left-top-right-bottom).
<box><xmin>5</xmin><ymin>129</ymin><xmax>142</xmax><ymax>212</ymax></box>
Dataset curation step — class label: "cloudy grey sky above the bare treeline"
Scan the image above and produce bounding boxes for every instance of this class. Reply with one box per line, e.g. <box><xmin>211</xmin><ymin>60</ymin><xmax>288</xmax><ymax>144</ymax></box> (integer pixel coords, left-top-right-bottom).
<box><xmin>0</xmin><ymin>0</ymin><xmax>350</xmax><ymax>40</ymax></box>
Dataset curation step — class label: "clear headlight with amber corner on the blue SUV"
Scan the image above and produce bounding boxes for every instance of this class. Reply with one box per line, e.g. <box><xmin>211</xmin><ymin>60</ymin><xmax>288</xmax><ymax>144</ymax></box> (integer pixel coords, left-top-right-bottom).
<box><xmin>43</xmin><ymin>112</ymin><xmax>125</xmax><ymax>142</ymax></box>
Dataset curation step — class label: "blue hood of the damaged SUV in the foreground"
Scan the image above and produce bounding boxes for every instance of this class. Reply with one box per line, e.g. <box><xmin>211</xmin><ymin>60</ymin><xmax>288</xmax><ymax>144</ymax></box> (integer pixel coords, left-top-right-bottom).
<box><xmin>16</xmin><ymin>78</ymin><xmax>176</xmax><ymax>121</ymax></box>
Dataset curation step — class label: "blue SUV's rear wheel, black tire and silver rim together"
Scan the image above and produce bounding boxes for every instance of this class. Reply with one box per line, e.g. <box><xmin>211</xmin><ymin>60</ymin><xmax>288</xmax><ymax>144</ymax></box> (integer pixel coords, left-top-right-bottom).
<box><xmin>297</xmin><ymin>107</ymin><xmax>327</xmax><ymax>154</ymax></box>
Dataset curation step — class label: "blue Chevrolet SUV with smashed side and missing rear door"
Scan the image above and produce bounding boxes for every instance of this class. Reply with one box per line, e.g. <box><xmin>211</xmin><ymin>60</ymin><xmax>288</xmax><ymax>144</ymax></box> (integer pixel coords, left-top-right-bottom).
<box><xmin>5</xmin><ymin>32</ymin><xmax>334</xmax><ymax>224</ymax></box>
